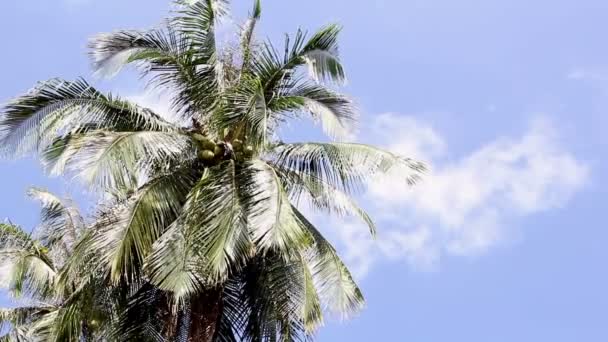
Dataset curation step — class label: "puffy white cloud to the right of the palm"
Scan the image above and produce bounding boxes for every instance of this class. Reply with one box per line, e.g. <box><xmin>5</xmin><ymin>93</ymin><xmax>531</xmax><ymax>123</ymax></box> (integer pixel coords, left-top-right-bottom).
<box><xmin>330</xmin><ymin>114</ymin><xmax>589</xmax><ymax>276</ymax></box>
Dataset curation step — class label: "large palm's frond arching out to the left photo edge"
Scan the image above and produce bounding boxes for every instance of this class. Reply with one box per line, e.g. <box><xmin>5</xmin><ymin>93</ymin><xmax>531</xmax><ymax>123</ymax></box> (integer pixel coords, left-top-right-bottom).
<box><xmin>0</xmin><ymin>79</ymin><xmax>174</xmax><ymax>157</ymax></box>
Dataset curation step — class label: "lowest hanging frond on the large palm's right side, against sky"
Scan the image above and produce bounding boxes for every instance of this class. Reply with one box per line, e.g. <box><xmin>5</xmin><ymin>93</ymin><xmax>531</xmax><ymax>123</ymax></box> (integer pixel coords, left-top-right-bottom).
<box><xmin>294</xmin><ymin>208</ymin><xmax>365</xmax><ymax>317</ymax></box>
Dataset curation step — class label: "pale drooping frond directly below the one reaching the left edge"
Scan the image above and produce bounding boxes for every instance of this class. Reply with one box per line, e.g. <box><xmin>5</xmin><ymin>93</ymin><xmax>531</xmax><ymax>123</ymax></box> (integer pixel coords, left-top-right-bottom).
<box><xmin>50</xmin><ymin>131</ymin><xmax>196</xmax><ymax>191</ymax></box>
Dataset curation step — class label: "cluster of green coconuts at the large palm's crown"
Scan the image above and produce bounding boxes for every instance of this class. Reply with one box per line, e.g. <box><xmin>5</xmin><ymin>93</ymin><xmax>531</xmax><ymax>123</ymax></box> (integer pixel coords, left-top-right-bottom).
<box><xmin>192</xmin><ymin>133</ymin><xmax>253</xmax><ymax>166</ymax></box>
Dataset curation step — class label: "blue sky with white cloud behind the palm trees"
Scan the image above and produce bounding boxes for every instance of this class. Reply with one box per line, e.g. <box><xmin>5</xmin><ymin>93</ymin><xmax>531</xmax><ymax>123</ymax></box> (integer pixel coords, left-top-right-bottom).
<box><xmin>0</xmin><ymin>0</ymin><xmax>608</xmax><ymax>342</ymax></box>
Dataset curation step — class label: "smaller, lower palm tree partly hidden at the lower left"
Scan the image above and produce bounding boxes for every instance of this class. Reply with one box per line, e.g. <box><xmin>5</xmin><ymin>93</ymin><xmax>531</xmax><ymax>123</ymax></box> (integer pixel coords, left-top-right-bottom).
<box><xmin>0</xmin><ymin>188</ymin><xmax>192</xmax><ymax>342</ymax></box>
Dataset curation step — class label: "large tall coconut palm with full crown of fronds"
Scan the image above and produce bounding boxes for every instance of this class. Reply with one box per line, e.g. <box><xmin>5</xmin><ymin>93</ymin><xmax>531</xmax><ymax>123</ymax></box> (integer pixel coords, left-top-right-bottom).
<box><xmin>0</xmin><ymin>0</ymin><xmax>424</xmax><ymax>341</ymax></box>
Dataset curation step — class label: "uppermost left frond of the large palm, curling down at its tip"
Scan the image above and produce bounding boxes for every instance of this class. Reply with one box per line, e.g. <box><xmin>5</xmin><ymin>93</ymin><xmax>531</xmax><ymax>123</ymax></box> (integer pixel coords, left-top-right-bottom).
<box><xmin>89</xmin><ymin>26</ymin><xmax>217</xmax><ymax>119</ymax></box>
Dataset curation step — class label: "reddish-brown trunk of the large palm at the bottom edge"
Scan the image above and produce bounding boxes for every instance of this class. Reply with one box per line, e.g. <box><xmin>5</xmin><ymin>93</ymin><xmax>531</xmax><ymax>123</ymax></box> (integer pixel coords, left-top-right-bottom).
<box><xmin>188</xmin><ymin>288</ymin><xmax>222</xmax><ymax>342</ymax></box>
